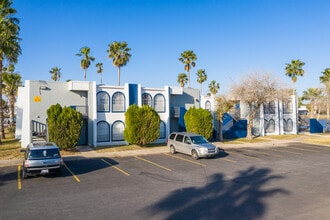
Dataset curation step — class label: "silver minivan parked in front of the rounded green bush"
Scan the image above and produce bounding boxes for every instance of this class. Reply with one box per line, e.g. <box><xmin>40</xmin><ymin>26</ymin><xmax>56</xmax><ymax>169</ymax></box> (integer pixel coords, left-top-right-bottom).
<box><xmin>167</xmin><ymin>132</ymin><xmax>219</xmax><ymax>160</ymax></box>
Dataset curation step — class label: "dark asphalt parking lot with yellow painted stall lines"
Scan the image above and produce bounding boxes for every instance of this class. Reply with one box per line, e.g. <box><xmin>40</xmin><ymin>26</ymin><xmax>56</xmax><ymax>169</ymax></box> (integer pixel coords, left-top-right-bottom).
<box><xmin>0</xmin><ymin>142</ymin><xmax>330</xmax><ymax>219</ymax></box>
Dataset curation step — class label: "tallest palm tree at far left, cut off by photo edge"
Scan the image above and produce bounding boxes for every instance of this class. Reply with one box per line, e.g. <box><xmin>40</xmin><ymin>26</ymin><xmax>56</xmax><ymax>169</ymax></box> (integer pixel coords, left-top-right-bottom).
<box><xmin>0</xmin><ymin>0</ymin><xmax>21</xmax><ymax>140</ymax></box>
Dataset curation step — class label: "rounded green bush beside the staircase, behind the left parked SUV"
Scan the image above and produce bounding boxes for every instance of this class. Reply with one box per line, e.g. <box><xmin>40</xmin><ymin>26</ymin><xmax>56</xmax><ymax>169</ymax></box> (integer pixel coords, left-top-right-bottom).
<box><xmin>47</xmin><ymin>104</ymin><xmax>83</xmax><ymax>150</ymax></box>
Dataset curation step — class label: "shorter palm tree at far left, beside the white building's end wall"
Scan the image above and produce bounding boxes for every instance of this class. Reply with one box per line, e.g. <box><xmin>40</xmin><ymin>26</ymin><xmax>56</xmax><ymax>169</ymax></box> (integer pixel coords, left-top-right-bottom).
<box><xmin>2</xmin><ymin>65</ymin><xmax>22</xmax><ymax>124</ymax></box>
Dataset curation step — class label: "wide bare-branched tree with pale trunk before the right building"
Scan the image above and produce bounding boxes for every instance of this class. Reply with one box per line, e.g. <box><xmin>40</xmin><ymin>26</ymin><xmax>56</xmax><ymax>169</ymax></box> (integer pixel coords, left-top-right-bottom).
<box><xmin>231</xmin><ymin>72</ymin><xmax>290</xmax><ymax>139</ymax></box>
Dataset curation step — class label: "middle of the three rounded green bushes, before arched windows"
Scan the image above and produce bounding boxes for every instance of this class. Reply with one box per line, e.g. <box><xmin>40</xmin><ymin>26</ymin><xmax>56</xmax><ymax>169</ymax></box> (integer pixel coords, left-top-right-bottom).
<box><xmin>124</xmin><ymin>105</ymin><xmax>160</xmax><ymax>146</ymax></box>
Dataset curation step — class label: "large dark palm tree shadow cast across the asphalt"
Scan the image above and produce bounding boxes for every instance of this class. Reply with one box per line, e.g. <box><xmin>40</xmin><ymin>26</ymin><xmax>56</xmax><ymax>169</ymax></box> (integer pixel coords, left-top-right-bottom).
<box><xmin>142</xmin><ymin>167</ymin><xmax>290</xmax><ymax>220</ymax></box>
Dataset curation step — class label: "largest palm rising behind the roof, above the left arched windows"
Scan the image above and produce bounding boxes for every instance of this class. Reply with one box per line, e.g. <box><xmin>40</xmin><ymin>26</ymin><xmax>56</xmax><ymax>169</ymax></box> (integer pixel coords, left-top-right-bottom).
<box><xmin>107</xmin><ymin>41</ymin><xmax>131</xmax><ymax>86</ymax></box>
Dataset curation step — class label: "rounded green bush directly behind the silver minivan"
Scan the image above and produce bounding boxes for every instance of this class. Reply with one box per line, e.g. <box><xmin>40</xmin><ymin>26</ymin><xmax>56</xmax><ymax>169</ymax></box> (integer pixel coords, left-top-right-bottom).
<box><xmin>184</xmin><ymin>107</ymin><xmax>213</xmax><ymax>139</ymax></box>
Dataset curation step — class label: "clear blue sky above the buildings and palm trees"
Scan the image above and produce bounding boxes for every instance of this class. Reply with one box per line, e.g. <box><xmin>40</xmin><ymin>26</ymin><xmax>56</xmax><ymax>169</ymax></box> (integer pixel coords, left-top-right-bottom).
<box><xmin>12</xmin><ymin>0</ymin><xmax>330</xmax><ymax>95</ymax></box>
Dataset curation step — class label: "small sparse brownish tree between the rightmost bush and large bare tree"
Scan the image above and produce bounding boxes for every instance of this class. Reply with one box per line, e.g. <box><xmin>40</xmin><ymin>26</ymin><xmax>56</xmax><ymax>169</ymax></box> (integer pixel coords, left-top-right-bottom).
<box><xmin>215</xmin><ymin>96</ymin><xmax>234</xmax><ymax>141</ymax></box>
